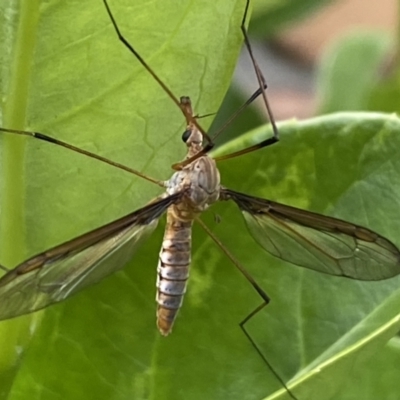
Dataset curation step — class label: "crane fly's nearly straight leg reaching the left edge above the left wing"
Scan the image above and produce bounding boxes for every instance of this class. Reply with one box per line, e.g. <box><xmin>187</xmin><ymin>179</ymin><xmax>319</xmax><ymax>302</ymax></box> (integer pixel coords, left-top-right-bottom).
<box><xmin>0</xmin><ymin>128</ymin><xmax>165</xmax><ymax>187</ymax></box>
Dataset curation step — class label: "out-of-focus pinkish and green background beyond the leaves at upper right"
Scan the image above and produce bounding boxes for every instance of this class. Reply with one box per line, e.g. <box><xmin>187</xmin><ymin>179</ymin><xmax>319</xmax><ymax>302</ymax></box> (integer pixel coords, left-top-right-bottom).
<box><xmin>214</xmin><ymin>0</ymin><xmax>399</xmax><ymax>143</ymax></box>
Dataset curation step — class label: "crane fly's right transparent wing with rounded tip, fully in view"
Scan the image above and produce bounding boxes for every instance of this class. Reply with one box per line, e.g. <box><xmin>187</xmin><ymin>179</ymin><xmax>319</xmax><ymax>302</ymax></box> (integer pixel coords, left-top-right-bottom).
<box><xmin>221</xmin><ymin>189</ymin><xmax>400</xmax><ymax>281</ymax></box>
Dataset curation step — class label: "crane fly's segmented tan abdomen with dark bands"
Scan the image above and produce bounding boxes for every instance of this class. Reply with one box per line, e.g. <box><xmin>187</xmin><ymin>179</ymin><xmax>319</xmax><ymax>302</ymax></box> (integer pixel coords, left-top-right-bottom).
<box><xmin>156</xmin><ymin>207</ymin><xmax>192</xmax><ymax>336</ymax></box>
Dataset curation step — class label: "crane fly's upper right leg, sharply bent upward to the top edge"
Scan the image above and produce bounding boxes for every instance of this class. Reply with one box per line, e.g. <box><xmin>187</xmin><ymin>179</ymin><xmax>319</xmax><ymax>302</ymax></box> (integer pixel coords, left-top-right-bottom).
<box><xmin>215</xmin><ymin>0</ymin><xmax>279</xmax><ymax>161</ymax></box>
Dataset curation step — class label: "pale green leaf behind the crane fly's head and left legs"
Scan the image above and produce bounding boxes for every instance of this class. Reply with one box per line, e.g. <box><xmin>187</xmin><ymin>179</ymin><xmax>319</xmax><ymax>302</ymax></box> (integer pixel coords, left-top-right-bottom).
<box><xmin>0</xmin><ymin>0</ymin><xmax>243</xmax><ymax>263</ymax></box>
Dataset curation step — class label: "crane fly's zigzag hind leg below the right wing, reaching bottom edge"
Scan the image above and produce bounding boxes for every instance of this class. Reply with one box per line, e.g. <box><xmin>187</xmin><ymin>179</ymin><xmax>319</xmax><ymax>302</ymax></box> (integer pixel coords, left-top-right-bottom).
<box><xmin>196</xmin><ymin>218</ymin><xmax>298</xmax><ymax>400</ymax></box>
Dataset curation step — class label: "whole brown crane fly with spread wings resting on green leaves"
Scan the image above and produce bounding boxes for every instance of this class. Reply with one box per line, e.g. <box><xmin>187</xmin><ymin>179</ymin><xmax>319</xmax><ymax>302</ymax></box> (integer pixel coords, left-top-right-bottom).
<box><xmin>0</xmin><ymin>0</ymin><xmax>400</xmax><ymax>400</ymax></box>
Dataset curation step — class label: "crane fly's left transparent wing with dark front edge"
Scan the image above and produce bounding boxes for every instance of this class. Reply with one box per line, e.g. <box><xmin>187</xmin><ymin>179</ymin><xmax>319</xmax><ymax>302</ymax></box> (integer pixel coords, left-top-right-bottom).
<box><xmin>0</xmin><ymin>193</ymin><xmax>180</xmax><ymax>320</ymax></box>
